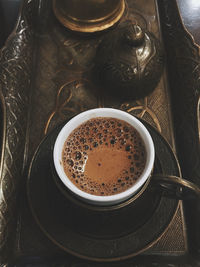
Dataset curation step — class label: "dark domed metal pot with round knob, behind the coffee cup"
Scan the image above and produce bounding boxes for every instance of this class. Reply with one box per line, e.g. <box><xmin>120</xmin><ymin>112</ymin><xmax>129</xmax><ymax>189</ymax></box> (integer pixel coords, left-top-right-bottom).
<box><xmin>95</xmin><ymin>21</ymin><xmax>164</xmax><ymax>99</ymax></box>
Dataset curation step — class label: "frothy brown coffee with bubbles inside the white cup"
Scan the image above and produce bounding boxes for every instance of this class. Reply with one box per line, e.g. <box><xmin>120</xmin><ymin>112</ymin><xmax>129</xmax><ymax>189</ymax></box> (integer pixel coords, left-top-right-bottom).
<box><xmin>62</xmin><ymin>117</ymin><xmax>146</xmax><ymax>196</ymax></box>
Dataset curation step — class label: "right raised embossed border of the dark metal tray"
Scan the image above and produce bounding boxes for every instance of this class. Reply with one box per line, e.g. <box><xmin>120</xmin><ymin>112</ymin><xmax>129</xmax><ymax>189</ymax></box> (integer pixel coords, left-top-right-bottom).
<box><xmin>160</xmin><ymin>0</ymin><xmax>200</xmax><ymax>256</ymax></box>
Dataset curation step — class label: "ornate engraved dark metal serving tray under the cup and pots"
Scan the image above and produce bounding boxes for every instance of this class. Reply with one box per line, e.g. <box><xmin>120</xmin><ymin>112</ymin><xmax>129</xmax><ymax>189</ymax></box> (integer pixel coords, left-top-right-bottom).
<box><xmin>0</xmin><ymin>0</ymin><xmax>200</xmax><ymax>266</ymax></box>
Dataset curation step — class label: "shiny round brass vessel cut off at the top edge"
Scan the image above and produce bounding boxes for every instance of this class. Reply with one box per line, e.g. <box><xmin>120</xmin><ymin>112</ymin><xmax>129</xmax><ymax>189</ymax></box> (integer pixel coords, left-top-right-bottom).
<box><xmin>53</xmin><ymin>0</ymin><xmax>125</xmax><ymax>33</ymax></box>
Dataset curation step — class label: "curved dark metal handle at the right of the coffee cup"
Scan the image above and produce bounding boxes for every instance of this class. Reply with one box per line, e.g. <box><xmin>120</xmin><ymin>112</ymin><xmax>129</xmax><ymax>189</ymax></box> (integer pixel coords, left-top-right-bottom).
<box><xmin>151</xmin><ymin>174</ymin><xmax>200</xmax><ymax>200</ymax></box>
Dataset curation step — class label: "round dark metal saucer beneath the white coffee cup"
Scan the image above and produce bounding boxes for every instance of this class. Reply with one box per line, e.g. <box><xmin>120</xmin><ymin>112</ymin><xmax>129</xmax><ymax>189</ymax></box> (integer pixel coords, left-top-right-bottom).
<box><xmin>28</xmin><ymin>120</ymin><xmax>180</xmax><ymax>261</ymax></box>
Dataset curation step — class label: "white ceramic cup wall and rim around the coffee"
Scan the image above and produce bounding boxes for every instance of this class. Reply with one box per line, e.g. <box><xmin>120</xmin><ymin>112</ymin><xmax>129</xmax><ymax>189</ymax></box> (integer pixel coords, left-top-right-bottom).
<box><xmin>53</xmin><ymin>108</ymin><xmax>155</xmax><ymax>206</ymax></box>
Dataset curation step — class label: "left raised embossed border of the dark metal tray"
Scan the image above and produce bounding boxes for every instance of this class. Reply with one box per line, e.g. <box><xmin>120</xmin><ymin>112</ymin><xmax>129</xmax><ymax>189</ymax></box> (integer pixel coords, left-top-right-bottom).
<box><xmin>0</xmin><ymin>1</ymin><xmax>37</xmax><ymax>266</ymax></box>
